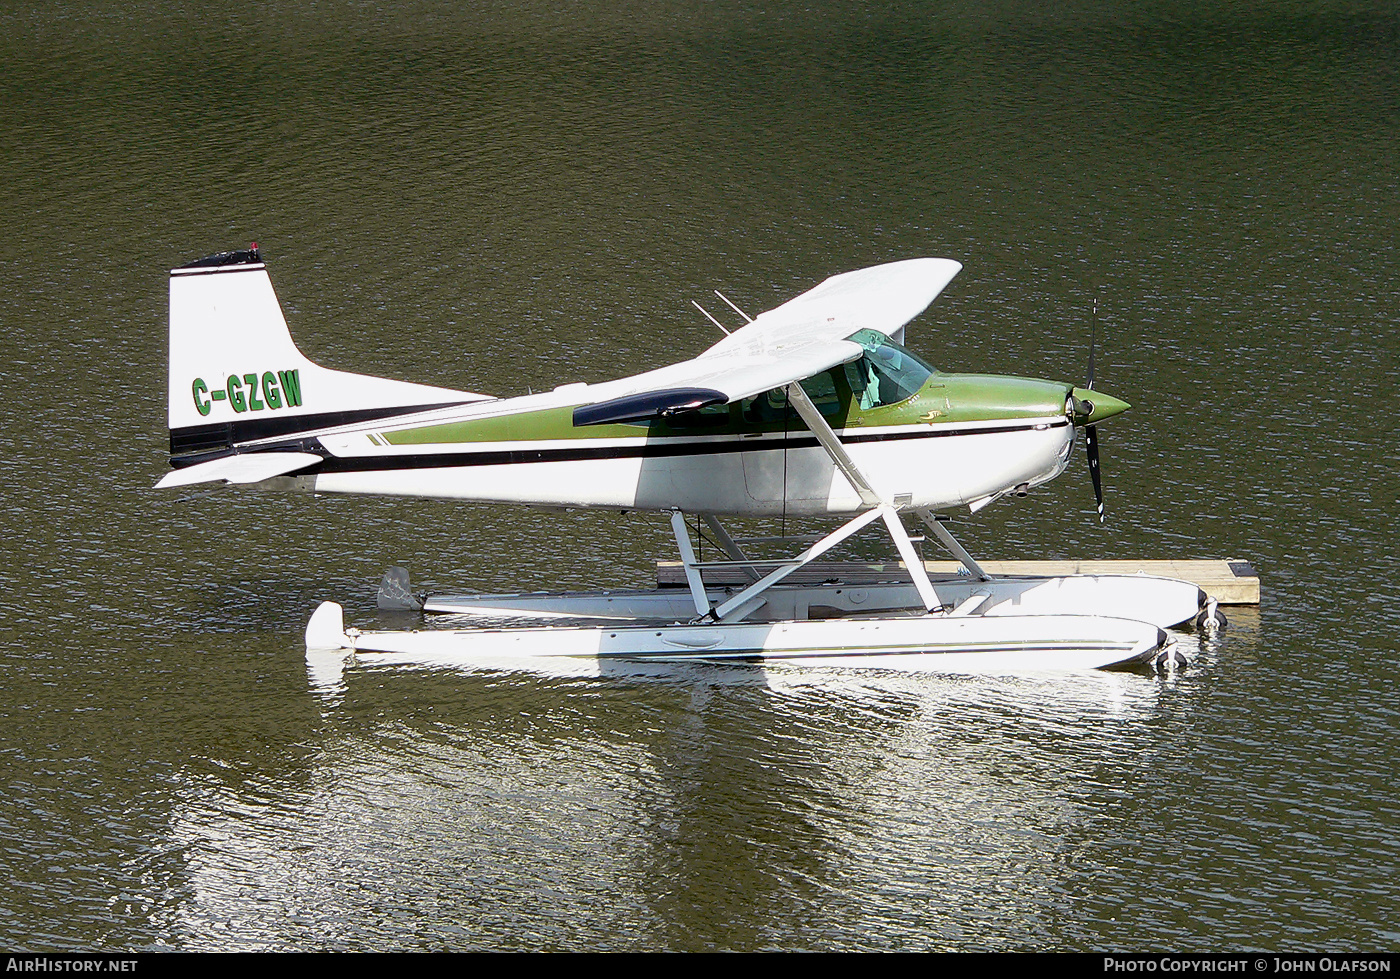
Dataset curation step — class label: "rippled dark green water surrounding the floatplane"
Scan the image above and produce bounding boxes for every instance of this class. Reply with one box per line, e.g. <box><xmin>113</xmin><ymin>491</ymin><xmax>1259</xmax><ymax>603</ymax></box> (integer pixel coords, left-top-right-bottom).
<box><xmin>0</xmin><ymin>0</ymin><xmax>1400</xmax><ymax>951</ymax></box>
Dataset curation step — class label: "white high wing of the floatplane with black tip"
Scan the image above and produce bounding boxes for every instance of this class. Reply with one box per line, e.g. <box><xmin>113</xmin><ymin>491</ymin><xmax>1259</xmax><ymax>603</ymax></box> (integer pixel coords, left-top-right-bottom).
<box><xmin>574</xmin><ymin>258</ymin><xmax>962</xmax><ymax>424</ymax></box>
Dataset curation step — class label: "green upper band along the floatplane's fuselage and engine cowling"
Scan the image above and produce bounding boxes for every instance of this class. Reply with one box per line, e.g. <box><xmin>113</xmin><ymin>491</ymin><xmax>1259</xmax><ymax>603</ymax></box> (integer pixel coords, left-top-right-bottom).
<box><xmin>381</xmin><ymin>374</ymin><xmax>1071</xmax><ymax>445</ymax></box>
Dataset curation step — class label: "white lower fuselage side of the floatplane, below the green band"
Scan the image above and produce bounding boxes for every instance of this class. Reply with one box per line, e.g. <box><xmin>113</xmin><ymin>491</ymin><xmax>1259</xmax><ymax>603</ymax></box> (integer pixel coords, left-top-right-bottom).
<box><xmin>314</xmin><ymin>416</ymin><xmax>1074</xmax><ymax>515</ymax></box>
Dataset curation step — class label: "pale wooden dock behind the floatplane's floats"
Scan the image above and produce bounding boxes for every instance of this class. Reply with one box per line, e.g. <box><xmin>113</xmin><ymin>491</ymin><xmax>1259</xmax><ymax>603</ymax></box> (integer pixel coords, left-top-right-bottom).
<box><xmin>657</xmin><ymin>559</ymin><xmax>1259</xmax><ymax>605</ymax></box>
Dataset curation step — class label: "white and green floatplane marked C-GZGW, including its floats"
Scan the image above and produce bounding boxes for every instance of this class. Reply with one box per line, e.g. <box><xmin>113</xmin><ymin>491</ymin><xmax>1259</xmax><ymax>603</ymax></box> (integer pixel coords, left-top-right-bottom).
<box><xmin>157</xmin><ymin>245</ymin><xmax>1207</xmax><ymax>672</ymax></box>
